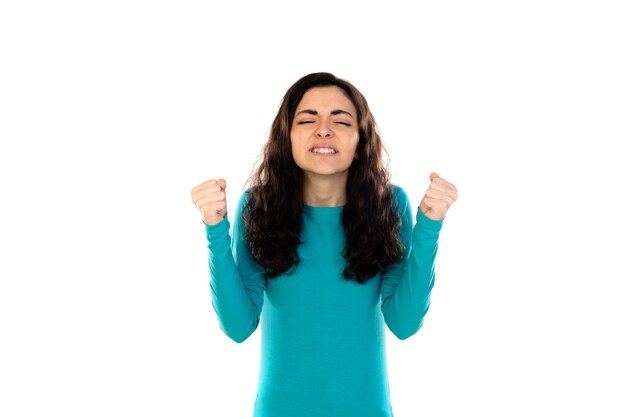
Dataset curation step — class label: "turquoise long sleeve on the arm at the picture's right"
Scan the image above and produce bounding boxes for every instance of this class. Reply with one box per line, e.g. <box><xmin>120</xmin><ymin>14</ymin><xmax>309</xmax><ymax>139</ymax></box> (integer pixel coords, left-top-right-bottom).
<box><xmin>381</xmin><ymin>186</ymin><xmax>443</xmax><ymax>340</ymax></box>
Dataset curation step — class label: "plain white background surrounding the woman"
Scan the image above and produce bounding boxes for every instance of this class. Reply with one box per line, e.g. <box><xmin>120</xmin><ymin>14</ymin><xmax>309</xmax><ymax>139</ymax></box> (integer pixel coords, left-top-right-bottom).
<box><xmin>0</xmin><ymin>0</ymin><xmax>626</xmax><ymax>417</ymax></box>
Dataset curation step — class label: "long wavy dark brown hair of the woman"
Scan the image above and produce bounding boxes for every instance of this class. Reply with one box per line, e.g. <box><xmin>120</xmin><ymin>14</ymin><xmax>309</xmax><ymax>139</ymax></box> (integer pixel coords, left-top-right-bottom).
<box><xmin>243</xmin><ymin>72</ymin><xmax>403</xmax><ymax>284</ymax></box>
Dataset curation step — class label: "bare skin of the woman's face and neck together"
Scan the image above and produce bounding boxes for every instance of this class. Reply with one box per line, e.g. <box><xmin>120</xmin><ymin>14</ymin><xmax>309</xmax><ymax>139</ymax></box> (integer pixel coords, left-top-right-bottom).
<box><xmin>290</xmin><ymin>86</ymin><xmax>359</xmax><ymax>207</ymax></box>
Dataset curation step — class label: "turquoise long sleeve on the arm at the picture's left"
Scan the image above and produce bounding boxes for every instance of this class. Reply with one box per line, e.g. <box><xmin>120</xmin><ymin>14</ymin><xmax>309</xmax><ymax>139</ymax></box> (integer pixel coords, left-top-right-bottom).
<box><xmin>202</xmin><ymin>192</ymin><xmax>266</xmax><ymax>343</ymax></box>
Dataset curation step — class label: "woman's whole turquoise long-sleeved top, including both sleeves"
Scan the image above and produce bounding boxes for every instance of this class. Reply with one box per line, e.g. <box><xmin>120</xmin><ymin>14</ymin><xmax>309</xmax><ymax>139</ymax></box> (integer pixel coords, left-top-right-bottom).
<box><xmin>203</xmin><ymin>186</ymin><xmax>443</xmax><ymax>417</ymax></box>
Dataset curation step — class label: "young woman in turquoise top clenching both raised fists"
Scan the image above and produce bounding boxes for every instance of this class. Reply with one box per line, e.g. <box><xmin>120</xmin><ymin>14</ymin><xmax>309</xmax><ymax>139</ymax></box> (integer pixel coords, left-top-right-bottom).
<box><xmin>191</xmin><ymin>73</ymin><xmax>457</xmax><ymax>417</ymax></box>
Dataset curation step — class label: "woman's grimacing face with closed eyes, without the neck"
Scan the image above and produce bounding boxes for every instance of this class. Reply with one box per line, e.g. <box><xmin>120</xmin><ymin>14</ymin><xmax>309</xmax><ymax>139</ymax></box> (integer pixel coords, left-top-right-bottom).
<box><xmin>291</xmin><ymin>86</ymin><xmax>359</xmax><ymax>180</ymax></box>
